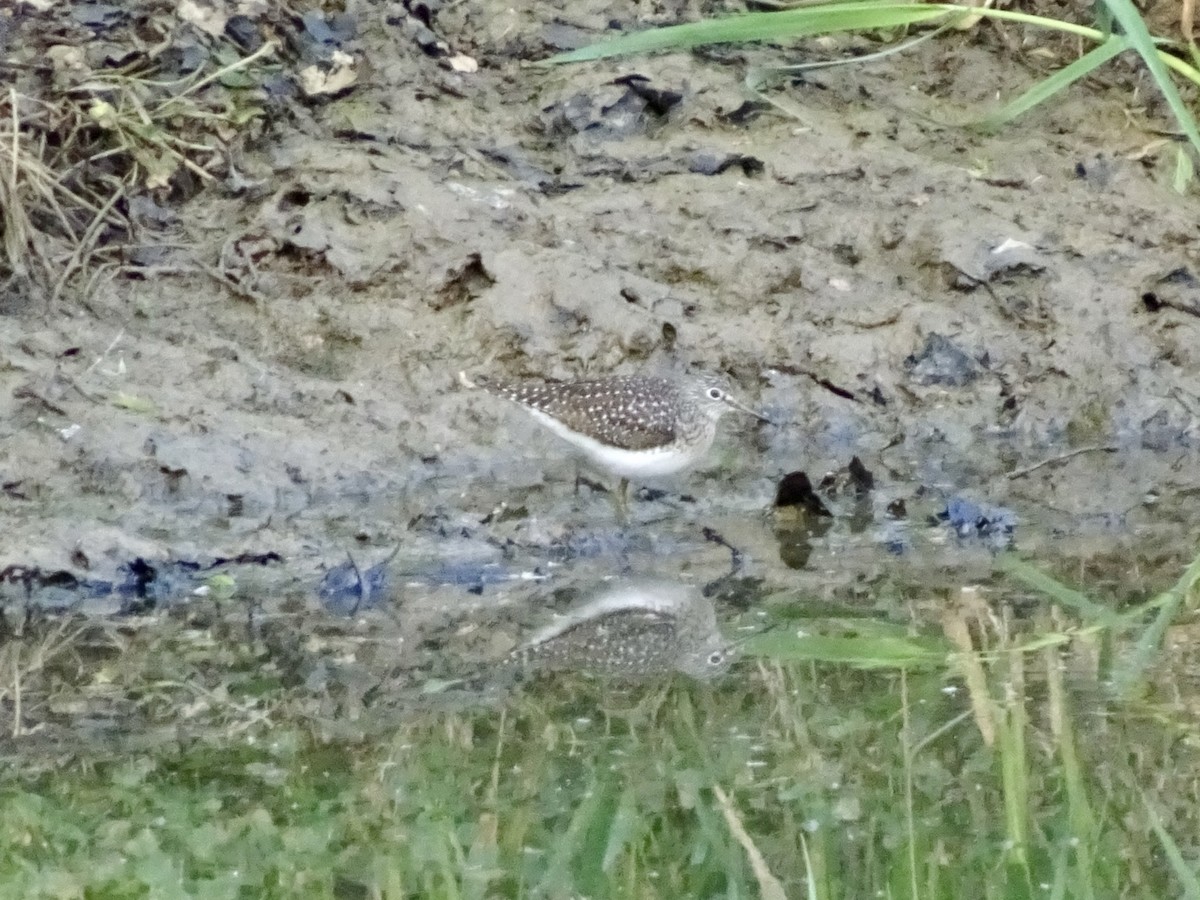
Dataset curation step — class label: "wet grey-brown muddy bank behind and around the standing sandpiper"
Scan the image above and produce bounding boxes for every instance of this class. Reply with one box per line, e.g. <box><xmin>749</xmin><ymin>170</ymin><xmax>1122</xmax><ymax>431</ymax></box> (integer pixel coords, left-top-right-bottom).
<box><xmin>0</xmin><ymin>1</ymin><xmax>1200</xmax><ymax>619</ymax></box>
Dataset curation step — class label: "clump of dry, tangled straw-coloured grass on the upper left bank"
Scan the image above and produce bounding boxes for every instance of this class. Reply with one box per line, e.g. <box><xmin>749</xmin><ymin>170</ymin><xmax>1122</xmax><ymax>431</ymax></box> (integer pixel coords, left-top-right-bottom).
<box><xmin>0</xmin><ymin>44</ymin><xmax>274</xmax><ymax>308</ymax></box>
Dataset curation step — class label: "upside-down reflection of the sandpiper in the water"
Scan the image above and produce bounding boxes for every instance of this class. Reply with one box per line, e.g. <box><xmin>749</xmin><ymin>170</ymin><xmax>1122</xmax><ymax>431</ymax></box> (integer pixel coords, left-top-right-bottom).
<box><xmin>509</xmin><ymin>581</ymin><xmax>734</xmax><ymax>678</ymax></box>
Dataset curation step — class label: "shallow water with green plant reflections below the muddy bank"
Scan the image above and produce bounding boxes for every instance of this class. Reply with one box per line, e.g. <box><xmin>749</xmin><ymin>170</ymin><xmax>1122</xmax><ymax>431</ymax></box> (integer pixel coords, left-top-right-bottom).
<box><xmin>4</xmin><ymin>475</ymin><xmax>1195</xmax><ymax>896</ymax></box>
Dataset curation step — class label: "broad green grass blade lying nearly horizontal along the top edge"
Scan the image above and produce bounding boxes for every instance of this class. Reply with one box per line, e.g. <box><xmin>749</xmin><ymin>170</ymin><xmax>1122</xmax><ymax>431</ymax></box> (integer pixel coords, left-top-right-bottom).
<box><xmin>545</xmin><ymin>0</ymin><xmax>962</xmax><ymax>65</ymax></box>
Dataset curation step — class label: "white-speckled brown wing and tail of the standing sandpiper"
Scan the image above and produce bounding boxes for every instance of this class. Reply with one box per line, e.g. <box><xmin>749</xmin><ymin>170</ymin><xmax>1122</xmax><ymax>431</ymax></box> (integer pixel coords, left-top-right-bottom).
<box><xmin>478</xmin><ymin>376</ymin><xmax>678</xmax><ymax>450</ymax></box>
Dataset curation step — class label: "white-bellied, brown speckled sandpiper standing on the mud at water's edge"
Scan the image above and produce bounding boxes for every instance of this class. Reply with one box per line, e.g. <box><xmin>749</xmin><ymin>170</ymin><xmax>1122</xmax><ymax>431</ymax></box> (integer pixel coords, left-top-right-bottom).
<box><xmin>458</xmin><ymin>372</ymin><xmax>767</xmax><ymax>511</ymax></box>
